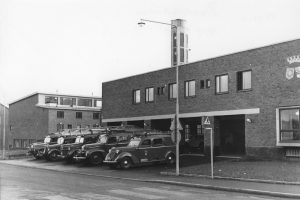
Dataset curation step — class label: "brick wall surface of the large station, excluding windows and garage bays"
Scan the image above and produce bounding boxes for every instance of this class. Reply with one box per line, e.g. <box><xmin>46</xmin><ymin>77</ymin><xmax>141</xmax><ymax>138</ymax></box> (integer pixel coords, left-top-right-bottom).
<box><xmin>102</xmin><ymin>40</ymin><xmax>300</xmax><ymax>157</ymax></box>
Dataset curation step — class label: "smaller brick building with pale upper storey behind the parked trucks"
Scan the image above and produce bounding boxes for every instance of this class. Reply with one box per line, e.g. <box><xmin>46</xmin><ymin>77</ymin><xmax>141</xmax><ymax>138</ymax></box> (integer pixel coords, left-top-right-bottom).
<box><xmin>9</xmin><ymin>93</ymin><xmax>102</xmax><ymax>148</ymax></box>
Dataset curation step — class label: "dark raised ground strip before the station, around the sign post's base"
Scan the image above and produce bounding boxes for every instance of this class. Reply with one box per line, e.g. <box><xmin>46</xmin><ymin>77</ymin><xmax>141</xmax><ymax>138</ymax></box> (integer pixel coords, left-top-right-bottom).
<box><xmin>166</xmin><ymin>156</ymin><xmax>300</xmax><ymax>185</ymax></box>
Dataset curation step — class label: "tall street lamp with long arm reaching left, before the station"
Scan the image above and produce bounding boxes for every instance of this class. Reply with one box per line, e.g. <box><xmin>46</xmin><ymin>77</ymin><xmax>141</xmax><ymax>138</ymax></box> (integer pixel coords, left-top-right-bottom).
<box><xmin>138</xmin><ymin>19</ymin><xmax>180</xmax><ymax>176</ymax></box>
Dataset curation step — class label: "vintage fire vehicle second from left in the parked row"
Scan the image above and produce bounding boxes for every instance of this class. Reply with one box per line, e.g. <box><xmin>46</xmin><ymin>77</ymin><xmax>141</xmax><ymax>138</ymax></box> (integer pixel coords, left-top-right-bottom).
<box><xmin>43</xmin><ymin>135</ymin><xmax>78</xmax><ymax>161</ymax></box>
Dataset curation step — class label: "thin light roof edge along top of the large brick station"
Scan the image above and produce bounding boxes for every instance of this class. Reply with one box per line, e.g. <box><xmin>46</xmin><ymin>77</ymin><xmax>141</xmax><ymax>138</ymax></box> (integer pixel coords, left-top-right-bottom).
<box><xmin>102</xmin><ymin>38</ymin><xmax>300</xmax><ymax>84</ymax></box>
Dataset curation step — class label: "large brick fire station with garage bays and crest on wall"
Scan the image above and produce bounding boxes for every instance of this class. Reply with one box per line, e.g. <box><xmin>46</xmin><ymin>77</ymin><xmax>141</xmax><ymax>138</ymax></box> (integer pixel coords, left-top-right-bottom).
<box><xmin>102</xmin><ymin>39</ymin><xmax>300</xmax><ymax>158</ymax></box>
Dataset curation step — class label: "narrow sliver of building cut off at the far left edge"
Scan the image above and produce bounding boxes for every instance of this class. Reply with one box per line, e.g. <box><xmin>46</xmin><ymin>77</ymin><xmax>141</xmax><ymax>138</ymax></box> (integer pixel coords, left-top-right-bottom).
<box><xmin>0</xmin><ymin>103</ymin><xmax>10</xmax><ymax>151</ymax></box>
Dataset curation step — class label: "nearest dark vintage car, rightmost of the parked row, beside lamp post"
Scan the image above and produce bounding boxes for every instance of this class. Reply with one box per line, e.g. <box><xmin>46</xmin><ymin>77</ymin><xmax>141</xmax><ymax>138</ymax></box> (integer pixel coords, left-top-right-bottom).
<box><xmin>104</xmin><ymin>134</ymin><xmax>176</xmax><ymax>169</ymax></box>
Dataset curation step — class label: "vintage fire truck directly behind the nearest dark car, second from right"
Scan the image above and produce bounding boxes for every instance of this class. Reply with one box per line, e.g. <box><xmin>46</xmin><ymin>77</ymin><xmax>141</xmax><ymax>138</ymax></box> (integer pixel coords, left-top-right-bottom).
<box><xmin>74</xmin><ymin>131</ymin><xmax>133</xmax><ymax>165</ymax></box>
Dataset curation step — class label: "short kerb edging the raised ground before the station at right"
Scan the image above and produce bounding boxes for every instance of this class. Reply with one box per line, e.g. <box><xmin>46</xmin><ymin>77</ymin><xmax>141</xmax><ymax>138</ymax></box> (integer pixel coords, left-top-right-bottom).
<box><xmin>160</xmin><ymin>172</ymin><xmax>300</xmax><ymax>185</ymax></box>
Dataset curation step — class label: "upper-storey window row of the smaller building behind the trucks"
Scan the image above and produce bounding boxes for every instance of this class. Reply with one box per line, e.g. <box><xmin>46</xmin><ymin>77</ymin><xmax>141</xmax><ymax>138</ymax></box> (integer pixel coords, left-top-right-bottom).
<box><xmin>45</xmin><ymin>96</ymin><xmax>102</xmax><ymax>107</ymax></box>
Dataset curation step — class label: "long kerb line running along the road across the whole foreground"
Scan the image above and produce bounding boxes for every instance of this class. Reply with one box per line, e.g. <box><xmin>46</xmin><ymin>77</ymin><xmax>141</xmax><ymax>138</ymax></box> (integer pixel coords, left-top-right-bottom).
<box><xmin>3</xmin><ymin>163</ymin><xmax>300</xmax><ymax>199</ymax></box>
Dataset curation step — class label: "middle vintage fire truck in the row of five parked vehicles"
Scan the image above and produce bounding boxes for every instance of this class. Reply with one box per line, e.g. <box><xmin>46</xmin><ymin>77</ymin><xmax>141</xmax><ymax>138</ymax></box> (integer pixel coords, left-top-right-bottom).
<box><xmin>58</xmin><ymin>129</ymin><xmax>106</xmax><ymax>162</ymax></box>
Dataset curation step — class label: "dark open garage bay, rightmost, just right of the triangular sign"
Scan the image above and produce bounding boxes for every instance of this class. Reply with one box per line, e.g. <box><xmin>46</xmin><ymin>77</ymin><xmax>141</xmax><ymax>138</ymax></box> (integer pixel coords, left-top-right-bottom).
<box><xmin>219</xmin><ymin>115</ymin><xmax>245</xmax><ymax>155</ymax></box>
